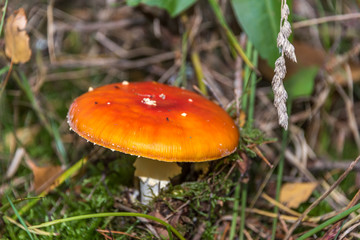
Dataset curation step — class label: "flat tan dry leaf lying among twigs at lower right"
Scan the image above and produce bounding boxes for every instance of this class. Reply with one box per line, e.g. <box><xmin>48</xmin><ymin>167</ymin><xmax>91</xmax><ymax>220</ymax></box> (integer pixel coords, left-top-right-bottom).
<box><xmin>280</xmin><ymin>182</ymin><xmax>317</xmax><ymax>208</ymax></box>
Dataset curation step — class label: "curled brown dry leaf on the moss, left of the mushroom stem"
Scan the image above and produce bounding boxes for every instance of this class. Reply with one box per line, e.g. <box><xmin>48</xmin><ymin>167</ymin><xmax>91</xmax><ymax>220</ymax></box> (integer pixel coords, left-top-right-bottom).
<box><xmin>26</xmin><ymin>159</ymin><xmax>64</xmax><ymax>194</ymax></box>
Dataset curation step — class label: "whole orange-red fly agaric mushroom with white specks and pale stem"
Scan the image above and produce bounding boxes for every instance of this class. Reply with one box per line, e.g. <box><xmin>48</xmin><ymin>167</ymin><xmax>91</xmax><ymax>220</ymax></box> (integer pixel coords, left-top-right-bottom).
<box><xmin>67</xmin><ymin>81</ymin><xmax>239</xmax><ymax>203</ymax></box>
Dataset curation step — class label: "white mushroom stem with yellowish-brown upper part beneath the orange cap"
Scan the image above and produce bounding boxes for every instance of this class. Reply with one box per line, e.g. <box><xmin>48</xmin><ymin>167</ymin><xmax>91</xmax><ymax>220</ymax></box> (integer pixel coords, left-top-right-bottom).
<box><xmin>134</xmin><ymin>157</ymin><xmax>181</xmax><ymax>204</ymax></box>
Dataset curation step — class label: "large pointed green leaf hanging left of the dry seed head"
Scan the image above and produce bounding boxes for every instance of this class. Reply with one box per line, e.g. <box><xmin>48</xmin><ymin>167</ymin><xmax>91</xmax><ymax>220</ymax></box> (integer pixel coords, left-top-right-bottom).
<box><xmin>231</xmin><ymin>0</ymin><xmax>281</xmax><ymax>68</ymax></box>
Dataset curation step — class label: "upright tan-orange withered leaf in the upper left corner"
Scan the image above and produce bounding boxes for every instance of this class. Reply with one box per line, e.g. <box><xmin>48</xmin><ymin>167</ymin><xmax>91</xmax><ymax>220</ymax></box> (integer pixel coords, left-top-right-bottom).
<box><xmin>5</xmin><ymin>8</ymin><xmax>31</xmax><ymax>63</ymax></box>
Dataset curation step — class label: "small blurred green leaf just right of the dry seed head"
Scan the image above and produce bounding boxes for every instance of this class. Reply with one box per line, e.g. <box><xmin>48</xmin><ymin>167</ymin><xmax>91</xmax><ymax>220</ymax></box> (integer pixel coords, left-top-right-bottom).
<box><xmin>284</xmin><ymin>67</ymin><xmax>318</xmax><ymax>99</ymax></box>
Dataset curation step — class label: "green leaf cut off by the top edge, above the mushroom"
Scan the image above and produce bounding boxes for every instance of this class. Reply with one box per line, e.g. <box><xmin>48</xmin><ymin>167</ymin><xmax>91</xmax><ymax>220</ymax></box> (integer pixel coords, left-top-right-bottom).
<box><xmin>126</xmin><ymin>0</ymin><xmax>196</xmax><ymax>17</ymax></box>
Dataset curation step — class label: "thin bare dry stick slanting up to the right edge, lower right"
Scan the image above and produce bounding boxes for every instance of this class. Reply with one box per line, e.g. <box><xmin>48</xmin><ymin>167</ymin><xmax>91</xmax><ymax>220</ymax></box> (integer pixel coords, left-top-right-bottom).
<box><xmin>285</xmin><ymin>155</ymin><xmax>360</xmax><ymax>240</ymax></box>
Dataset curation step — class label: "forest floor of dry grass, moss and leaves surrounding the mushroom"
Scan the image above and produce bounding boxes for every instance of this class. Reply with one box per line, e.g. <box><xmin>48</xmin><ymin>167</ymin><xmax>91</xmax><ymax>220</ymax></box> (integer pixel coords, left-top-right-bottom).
<box><xmin>0</xmin><ymin>0</ymin><xmax>360</xmax><ymax>240</ymax></box>
